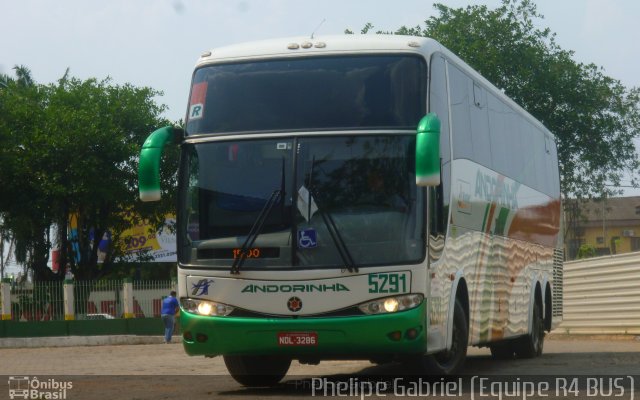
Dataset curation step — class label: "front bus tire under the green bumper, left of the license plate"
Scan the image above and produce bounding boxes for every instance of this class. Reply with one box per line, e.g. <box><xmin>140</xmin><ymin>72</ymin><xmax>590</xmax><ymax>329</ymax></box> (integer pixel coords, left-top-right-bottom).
<box><xmin>223</xmin><ymin>356</ymin><xmax>291</xmax><ymax>387</ymax></box>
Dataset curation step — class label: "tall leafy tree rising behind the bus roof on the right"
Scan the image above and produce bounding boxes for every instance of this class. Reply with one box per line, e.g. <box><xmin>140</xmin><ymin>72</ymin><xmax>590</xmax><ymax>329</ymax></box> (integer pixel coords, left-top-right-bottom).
<box><xmin>346</xmin><ymin>0</ymin><xmax>640</xmax><ymax>198</ymax></box>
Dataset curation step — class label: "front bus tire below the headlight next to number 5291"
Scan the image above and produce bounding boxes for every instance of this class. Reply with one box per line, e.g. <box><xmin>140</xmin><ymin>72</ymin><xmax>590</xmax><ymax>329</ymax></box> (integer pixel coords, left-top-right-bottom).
<box><xmin>423</xmin><ymin>299</ymin><xmax>469</xmax><ymax>376</ymax></box>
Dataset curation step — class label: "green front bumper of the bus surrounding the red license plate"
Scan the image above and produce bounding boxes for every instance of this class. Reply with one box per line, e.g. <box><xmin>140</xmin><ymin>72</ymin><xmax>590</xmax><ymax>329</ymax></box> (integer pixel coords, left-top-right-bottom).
<box><xmin>180</xmin><ymin>302</ymin><xmax>427</xmax><ymax>359</ymax></box>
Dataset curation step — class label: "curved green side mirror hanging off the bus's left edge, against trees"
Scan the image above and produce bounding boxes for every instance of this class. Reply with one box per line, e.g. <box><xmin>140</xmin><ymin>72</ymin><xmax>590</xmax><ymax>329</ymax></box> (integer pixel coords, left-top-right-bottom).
<box><xmin>138</xmin><ymin>126</ymin><xmax>177</xmax><ymax>201</ymax></box>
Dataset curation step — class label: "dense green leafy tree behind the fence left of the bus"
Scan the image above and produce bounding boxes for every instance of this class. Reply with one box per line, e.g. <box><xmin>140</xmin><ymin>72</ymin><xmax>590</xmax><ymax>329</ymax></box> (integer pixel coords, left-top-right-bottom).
<box><xmin>0</xmin><ymin>67</ymin><xmax>177</xmax><ymax>280</ymax></box>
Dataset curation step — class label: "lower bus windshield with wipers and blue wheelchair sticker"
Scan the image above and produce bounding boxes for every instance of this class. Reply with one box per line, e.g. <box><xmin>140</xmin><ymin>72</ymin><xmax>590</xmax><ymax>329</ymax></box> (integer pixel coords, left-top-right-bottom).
<box><xmin>178</xmin><ymin>134</ymin><xmax>425</xmax><ymax>269</ymax></box>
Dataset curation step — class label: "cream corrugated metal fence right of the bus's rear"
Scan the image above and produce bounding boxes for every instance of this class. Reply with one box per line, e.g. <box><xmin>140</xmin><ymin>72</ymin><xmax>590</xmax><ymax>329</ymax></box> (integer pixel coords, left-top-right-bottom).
<box><xmin>558</xmin><ymin>252</ymin><xmax>640</xmax><ymax>335</ymax></box>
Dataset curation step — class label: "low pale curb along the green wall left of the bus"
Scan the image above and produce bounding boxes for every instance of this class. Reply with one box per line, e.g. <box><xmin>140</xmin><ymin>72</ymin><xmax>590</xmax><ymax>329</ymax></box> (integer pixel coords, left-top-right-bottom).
<box><xmin>0</xmin><ymin>335</ymin><xmax>170</xmax><ymax>349</ymax></box>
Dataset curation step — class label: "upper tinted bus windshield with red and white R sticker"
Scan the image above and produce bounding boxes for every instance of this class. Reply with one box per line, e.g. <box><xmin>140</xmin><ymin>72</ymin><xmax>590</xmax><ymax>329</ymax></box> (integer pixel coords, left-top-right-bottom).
<box><xmin>186</xmin><ymin>55</ymin><xmax>427</xmax><ymax>135</ymax></box>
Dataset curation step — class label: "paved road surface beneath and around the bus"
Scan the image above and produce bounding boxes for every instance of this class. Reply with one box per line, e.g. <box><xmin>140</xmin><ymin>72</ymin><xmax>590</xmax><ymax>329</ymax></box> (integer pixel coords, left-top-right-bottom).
<box><xmin>0</xmin><ymin>336</ymin><xmax>640</xmax><ymax>400</ymax></box>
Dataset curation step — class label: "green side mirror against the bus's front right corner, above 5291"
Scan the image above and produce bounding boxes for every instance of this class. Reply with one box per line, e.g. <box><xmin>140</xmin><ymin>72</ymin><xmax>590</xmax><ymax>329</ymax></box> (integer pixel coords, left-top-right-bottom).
<box><xmin>416</xmin><ymin>113</ymin><xmax>440</xmax><ymax>186</ymax></box>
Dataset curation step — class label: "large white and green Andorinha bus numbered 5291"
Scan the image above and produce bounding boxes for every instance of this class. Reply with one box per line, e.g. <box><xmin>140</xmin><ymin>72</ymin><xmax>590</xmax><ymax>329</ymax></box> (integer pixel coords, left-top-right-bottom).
<box><xmin>140</xmin><ymin>35</ymin><xmax>562</xmax><ymax>386</ymax></box>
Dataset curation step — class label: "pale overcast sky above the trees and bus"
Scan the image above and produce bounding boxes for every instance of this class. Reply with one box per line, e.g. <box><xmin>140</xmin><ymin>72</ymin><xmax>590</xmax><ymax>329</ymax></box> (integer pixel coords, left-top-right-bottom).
<box><xmin>0</xmin><ymin>0</ymin><xmax>640</xmax><ymax>120</ymax></box>
